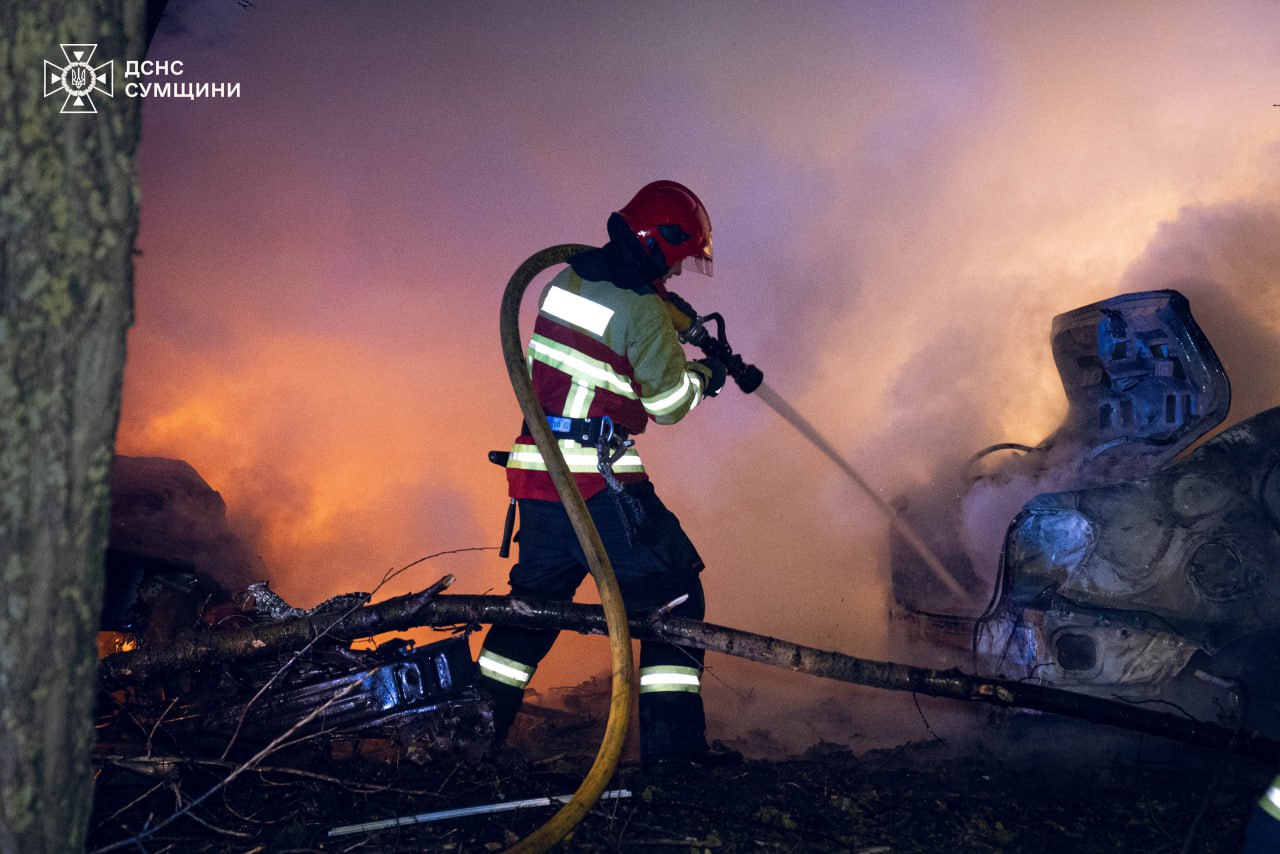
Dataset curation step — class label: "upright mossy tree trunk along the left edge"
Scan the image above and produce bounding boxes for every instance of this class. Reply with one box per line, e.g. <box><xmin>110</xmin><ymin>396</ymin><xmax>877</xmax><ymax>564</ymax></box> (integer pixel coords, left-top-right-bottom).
<box><xmin>0</xmin><ymin>0</ymin><xmax>142</xmax><ymax>854</ymax></box>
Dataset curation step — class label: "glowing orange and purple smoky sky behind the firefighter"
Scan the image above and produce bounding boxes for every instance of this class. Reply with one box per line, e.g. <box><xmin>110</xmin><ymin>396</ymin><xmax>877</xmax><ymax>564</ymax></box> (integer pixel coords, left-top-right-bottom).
<box><xmin>119</xmin><ymin>0</ymin><xmax>1280</xmax><ymax>747</ymax></box>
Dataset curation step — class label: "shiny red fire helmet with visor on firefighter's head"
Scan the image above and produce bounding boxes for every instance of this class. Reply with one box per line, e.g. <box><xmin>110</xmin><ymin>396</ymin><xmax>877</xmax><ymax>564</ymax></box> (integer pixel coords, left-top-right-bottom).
<box><xmin>618</xmin><ymin>181</ymin><xmax>712</xmax><ymax>275</ymax></box>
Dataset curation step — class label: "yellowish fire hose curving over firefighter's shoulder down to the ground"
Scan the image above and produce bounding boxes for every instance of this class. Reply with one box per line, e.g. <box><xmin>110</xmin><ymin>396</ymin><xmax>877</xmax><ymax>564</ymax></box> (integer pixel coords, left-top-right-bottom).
<box><xmin>502</xmin><ymin>243</ymin><xmax>631</xmax><ymax>854</ymax></box>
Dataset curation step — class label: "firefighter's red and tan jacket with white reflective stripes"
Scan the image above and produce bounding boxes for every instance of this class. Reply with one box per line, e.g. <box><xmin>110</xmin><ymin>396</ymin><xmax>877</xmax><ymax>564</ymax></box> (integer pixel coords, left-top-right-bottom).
<box><xmin>507</xmin><ymin>268</ymin><xmax>710</xmax><ymax>501</ymax></box>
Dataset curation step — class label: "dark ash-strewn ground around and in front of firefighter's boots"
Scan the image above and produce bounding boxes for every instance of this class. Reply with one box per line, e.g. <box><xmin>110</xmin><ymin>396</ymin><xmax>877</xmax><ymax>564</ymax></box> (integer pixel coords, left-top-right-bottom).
<box><xmin>90</xmin><ymin>680</ymin><xmax>1274</xmax><ymax>854</ymax></box>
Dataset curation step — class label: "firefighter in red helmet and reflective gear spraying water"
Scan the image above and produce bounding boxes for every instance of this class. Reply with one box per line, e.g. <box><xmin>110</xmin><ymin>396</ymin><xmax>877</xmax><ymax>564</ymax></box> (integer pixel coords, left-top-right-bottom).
<box><xmin>479</xmin><ymin>181</ymin><xmax>742</xmax><ymax>769</ymax></box>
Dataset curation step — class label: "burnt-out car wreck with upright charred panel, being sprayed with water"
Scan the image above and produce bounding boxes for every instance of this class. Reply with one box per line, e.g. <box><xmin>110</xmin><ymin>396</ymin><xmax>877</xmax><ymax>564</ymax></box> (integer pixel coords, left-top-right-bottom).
<box><xmin>893</xmin><ymin>291</ymin><xmax>1280</xmax><ymax>737</ymax></box>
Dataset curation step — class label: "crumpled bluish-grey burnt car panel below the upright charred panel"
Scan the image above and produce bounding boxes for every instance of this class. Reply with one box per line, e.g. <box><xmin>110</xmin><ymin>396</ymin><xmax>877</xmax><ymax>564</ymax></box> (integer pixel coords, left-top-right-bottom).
<box><xmin>1001</xmin><ymin>407</ymin><xmax>1280</xmax><ymax>653</ymax></box>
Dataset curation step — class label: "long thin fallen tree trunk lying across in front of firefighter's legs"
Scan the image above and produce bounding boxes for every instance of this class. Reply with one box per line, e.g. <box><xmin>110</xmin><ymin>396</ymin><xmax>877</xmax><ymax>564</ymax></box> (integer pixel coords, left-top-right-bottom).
<box><xmin>101</xmin><ymin>585</ymin><xmax>1280</xmax><ymax>759</ymax></box>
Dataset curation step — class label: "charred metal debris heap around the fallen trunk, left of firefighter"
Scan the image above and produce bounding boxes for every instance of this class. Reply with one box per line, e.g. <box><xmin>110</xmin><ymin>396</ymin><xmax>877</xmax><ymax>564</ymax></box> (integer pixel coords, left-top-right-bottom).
<box><xmin>99</xmin><ymin>575</ymin><xmax>493</xmax><ymax>761</ymax></box>
